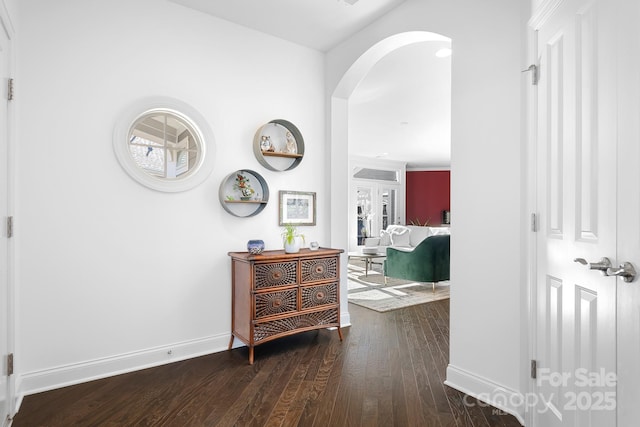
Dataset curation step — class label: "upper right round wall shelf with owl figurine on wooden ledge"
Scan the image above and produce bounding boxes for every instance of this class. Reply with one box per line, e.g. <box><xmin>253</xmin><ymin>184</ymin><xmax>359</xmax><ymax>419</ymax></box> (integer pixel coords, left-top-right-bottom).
<box><xmin>253</xmin><ymin>119</ymin><xmax>304</xmax><ymax>172</ymax></box>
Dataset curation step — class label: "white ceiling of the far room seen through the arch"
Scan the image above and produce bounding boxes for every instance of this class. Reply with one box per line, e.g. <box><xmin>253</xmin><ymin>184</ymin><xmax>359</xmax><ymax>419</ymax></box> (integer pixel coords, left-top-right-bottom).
<box><xmin>349</xmin><ymin>41</ymin><xmax>451</xmax><ymax>169</ymax></box>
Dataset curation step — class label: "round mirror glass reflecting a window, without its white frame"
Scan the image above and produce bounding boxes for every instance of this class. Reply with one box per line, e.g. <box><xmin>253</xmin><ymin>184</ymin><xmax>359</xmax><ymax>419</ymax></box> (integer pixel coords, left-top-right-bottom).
<box><xmin>129</xmin><ymin>112</ymin><xmax>201</xmax><ymax>179</ymax></box>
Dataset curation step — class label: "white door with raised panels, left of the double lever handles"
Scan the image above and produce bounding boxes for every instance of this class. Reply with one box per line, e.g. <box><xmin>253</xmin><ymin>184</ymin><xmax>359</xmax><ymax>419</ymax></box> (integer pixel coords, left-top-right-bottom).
<box><xmin>533</xmin><ymin>0</ymin><xmax>618</xmax><ymax>427</ymax></box>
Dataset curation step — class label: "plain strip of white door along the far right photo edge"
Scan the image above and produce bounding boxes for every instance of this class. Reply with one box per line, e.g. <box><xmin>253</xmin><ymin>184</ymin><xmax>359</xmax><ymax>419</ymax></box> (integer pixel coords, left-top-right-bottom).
<box><xmin>615</xmin><ymin>0</ymin><xmax>640</xmax><ymax>426</ymax></box>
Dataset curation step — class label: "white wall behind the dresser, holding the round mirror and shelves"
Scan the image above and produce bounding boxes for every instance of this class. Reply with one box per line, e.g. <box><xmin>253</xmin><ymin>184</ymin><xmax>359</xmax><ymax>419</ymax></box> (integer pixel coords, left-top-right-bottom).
<box><xmin>14</xmin><ymin>0</ymin><xmax>330</xmax><ymax>393</ymax></box>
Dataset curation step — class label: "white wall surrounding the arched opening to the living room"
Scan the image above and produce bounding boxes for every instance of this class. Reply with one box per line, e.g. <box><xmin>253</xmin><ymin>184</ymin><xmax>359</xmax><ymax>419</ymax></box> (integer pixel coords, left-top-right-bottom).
<box><xmin>327</xmin><ymin>0</ymin><xmax>528</xmax><ymax>417</ymax></box>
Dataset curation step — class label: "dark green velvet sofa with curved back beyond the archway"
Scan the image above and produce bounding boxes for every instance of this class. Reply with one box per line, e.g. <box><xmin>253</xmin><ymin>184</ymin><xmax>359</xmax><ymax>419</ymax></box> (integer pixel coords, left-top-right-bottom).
<box><xmin>382</xmin><ymin>235</ymin><xmax>451</xmax><ymax>289</ymax></box>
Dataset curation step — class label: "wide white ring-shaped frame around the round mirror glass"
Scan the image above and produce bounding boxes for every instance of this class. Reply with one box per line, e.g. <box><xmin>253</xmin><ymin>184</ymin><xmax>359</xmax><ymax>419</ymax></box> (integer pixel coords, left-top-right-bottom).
<box><xmin>113</xmin><ymin>97</ymin><xmax>215</xmax><ymax>193</ymax></box>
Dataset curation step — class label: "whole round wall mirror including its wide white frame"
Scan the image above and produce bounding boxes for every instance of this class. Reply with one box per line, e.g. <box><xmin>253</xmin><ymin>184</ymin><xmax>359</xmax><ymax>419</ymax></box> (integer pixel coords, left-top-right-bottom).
<box><xmin>113</xmin><ymin>98</ymin><xmax>213</xmax><ymax>191</ymax></box>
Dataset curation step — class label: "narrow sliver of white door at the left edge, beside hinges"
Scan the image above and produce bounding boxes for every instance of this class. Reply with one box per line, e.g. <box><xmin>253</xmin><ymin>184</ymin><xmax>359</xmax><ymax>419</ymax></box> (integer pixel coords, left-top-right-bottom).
<box><xmin>0</xmin><ymin>15</ymin><xmax>11</xmax><ymax>425</ymax></box>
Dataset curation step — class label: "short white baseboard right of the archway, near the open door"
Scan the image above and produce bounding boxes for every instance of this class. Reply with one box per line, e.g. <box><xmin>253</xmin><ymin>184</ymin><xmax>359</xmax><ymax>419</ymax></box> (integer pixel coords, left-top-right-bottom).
<box><xmin>444</xmin><ymin>365</ymin><xmax>524</xmax><ymax>425</ymax></box>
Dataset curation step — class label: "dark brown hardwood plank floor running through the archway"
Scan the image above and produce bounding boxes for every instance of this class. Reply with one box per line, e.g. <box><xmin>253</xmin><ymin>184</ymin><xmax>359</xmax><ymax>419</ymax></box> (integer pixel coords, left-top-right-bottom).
<box><xmin>13</xmin><ymin>300</ymin><xmax>520</xmax><ymax>427</ymax></box>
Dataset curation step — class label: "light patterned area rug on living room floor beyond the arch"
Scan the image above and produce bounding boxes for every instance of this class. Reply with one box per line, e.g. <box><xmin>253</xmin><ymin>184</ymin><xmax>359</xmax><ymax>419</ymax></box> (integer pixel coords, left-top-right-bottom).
<box><xmin>347</xmin><ymin>261</ymin><xmax>449</xmax><ymax>313</ymax></box>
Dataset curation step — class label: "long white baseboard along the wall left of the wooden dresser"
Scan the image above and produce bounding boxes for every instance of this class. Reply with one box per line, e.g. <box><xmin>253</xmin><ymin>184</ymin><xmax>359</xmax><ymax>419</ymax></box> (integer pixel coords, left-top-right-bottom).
<box><xmin>16</xmin><ymin>334</ymin><xmax>231</xmax><ymax>402</ymax></box>
